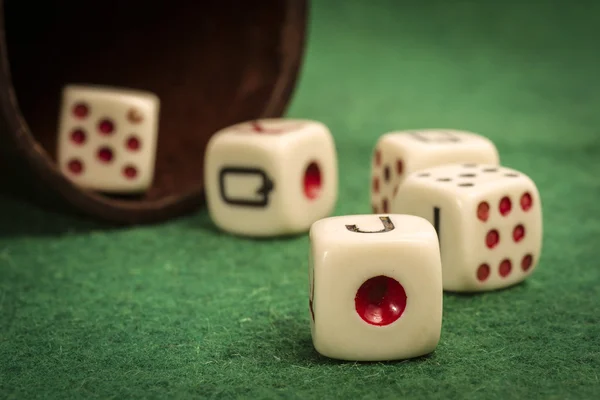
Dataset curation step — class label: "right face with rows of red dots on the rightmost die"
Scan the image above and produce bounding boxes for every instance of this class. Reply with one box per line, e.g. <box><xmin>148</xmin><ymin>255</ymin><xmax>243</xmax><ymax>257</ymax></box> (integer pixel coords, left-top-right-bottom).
<box><xmin>457</xmin><ymin>166</ymin><xmax>542</xmax><ymax>291</ymax></box>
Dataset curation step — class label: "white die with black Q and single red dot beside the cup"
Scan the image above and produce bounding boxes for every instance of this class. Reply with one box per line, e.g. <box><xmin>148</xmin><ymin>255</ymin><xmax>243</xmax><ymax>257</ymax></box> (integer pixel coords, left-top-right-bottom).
<box><xmin>204</xmin><ymin>119</ymin><xmax>338</xmax><ymax>236</ymax></box>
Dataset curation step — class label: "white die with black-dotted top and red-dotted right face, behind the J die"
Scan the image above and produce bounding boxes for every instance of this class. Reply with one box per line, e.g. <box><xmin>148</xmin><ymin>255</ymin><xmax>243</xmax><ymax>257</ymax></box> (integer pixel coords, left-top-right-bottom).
<box><xmin>392</xmin><ymin>164</ymin><xmax>542</xmax><ymax>292</ymax></box>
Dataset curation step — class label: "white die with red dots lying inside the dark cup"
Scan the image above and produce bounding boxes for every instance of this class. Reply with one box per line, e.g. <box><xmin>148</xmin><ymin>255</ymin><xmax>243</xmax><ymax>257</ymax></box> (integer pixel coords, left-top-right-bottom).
<box><xmin>58</xmin><ymin>85</ymin><xmax>160</xmax><ymax>193</ymax></box>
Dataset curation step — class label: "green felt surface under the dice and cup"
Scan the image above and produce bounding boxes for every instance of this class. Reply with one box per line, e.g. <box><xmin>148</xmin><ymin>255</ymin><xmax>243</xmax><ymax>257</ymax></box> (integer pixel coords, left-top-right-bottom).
<box><xmin>0</xmin><ymin>0</ymin><xmax>600</xmax><ymax>399</ymax></box>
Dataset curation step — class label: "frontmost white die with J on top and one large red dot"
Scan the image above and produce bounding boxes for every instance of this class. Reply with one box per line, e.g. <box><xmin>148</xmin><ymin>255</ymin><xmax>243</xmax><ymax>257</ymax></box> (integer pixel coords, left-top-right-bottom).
<box><xmin>309</xmin><ymin>214</ymin><xmax>443</xmax><ymax>361</ymax></box>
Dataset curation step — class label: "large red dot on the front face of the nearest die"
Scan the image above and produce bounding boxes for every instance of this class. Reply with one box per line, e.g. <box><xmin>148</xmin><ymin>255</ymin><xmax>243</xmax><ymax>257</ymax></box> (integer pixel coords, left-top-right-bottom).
<box><xmin>354</xmin><ymin>275</ymin><xmax>406</xmax><ymax>326</ymax></box>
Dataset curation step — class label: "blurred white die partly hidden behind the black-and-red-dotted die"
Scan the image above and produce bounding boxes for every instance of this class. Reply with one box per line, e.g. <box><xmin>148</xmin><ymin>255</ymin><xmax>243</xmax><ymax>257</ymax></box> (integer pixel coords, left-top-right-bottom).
<box><xmin>371</xmin><ymin>129</ymin><xmax>500</xmax><ymax>213</ymax></box>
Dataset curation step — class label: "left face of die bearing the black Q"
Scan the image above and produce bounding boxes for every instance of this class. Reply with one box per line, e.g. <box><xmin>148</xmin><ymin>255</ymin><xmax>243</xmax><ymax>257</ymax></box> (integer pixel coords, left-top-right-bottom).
<box><xmin>204</xmin><ymin>130</ymin><xmax>285</xmax><ymax>236</ymax></box>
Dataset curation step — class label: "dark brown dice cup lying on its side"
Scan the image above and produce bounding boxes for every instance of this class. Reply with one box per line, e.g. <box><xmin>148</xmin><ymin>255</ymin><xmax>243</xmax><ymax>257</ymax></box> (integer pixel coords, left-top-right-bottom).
<box><xmin>0</xmin><ymin>0</ymin><xmax>308</xmax><ymax>224</ymax></box>
